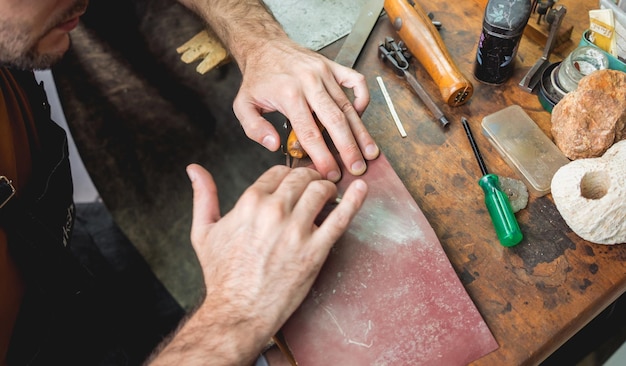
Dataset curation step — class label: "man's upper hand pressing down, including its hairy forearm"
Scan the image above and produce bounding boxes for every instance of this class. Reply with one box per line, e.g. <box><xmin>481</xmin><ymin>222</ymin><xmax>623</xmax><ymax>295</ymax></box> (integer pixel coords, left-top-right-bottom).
<box><xmin>180</xmin><ymin>0</ymin><xmax>380</xmax><ymax>181</ymax></box>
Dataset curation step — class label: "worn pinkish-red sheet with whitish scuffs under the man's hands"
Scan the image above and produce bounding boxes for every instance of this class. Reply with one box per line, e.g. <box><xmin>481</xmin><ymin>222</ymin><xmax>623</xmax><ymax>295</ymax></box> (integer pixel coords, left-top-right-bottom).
<box><xmin>283</xmin><ymin>154</ymin><xmax>498</xmax><ymax>366</ymax></box>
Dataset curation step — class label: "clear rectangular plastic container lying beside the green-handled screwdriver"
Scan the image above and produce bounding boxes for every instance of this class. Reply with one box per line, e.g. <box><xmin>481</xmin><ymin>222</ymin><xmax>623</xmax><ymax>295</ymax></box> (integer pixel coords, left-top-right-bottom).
<box><xmin>482</xmin><ymin>105</ymin><xmax>570</xmax><ymax>196</ymax></box>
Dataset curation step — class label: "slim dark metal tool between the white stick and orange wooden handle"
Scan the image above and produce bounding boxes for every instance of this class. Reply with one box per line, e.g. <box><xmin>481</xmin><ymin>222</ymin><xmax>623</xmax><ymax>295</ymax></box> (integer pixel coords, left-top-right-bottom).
<box><xmin>378</xmin><ymin>37</ymin><xmax>449</xmax><ymax>127</ymax></box>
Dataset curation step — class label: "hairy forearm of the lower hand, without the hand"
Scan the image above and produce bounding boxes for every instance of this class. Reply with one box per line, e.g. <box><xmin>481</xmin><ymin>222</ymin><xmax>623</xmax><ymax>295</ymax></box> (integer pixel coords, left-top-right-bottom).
<box><xmin>147</xmin><ymin>302</ymin><xmax>269</xmax><ymax>366</ymax></box>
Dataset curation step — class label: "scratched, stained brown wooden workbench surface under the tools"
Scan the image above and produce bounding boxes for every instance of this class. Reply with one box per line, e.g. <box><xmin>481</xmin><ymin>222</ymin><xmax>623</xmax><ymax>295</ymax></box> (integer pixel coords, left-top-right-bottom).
<box><xmin>346</xmin><ymin>0</ymin><xmax>626</xmax><ymax>365</ymax></box>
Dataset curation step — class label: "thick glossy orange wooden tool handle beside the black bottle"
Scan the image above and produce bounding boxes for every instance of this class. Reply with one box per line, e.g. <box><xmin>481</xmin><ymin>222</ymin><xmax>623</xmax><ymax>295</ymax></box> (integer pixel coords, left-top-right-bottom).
<box><xmin>385</xmin><ymin>0</ymin><xmax>474</xmax><ymax>107</ymax></box>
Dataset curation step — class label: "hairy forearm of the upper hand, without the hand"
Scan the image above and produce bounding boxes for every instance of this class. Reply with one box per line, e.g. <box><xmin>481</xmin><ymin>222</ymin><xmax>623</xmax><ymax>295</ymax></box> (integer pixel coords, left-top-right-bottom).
<box><xmin>179</xmin><ymin>0</ymin><xmax>289</xmax><ymax>69</ymax></box>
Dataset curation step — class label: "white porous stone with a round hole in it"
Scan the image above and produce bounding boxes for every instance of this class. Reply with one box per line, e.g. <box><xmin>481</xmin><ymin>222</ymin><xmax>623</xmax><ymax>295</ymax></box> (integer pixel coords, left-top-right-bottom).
<box><xmin>551</xmin><ymin>140</ymin><xmax>626</xmax><ymax>244</ymax></box>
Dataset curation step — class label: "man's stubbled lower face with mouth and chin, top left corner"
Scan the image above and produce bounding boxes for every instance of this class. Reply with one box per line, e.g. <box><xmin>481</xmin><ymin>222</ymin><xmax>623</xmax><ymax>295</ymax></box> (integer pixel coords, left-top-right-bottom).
<box><xmin>0</xmin><ymin>0</ymin><xmax>89</xmax><ymax>69</ymax></box>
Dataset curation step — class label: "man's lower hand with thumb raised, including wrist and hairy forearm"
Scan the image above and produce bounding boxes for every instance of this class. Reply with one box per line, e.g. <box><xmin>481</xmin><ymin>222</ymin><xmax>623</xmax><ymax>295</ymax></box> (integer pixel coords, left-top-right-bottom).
<box><xmin>149</xmin><ymin>164</ymin><xmax>367</xmax><ymax>364</ymax></box>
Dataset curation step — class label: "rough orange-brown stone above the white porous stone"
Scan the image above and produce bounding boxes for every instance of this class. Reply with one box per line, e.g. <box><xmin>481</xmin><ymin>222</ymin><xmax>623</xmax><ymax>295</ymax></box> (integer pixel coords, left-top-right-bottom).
<box><xmin>552</xmin><ymin>70</ymin><xmax>626</xmax><ymax>160</ymax></box>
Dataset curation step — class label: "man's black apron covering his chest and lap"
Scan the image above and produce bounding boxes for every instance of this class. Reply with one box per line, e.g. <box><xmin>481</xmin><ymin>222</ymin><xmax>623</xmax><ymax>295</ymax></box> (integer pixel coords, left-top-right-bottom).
<box><xmin>0</xmin><ymin>72</ymin><xmax>184</xmax><ymax>365</ymax></box>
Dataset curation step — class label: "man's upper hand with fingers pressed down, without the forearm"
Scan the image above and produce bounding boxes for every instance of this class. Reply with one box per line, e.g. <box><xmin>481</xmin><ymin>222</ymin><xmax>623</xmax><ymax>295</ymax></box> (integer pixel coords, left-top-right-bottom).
<box><xmin>234</xmin><ymin>39</ymin><xmax>379</xmax><ymax>181</ymax></box>
